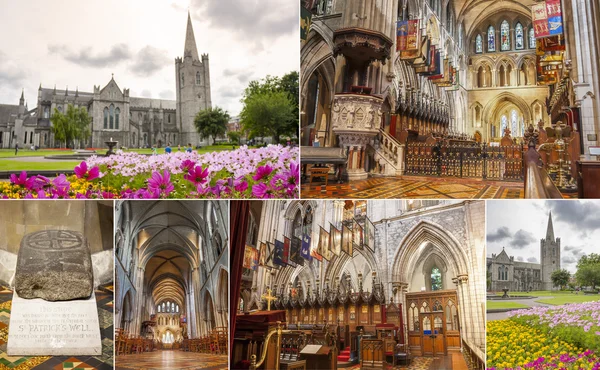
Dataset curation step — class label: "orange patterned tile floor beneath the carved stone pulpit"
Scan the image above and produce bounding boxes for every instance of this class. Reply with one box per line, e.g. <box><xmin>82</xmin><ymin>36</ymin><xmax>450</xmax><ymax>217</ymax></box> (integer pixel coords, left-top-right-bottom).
<box><xmin>302</xmin><ymin>176</ymin><xmax>523</xmax><ymax>199</ymax></box>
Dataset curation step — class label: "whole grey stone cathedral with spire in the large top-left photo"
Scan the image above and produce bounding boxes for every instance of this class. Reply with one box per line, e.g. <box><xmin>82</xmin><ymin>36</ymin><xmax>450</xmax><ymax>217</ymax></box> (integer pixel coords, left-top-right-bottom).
<box><xmin>0</xmin><ymin>13</ymin><xmax>211</xmax><ymax>148</ymax></box>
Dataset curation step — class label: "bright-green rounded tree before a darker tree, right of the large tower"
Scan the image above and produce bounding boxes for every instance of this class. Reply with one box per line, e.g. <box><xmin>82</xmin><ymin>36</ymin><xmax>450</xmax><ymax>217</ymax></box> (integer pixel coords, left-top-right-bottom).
<box><xmin>240</xmin><ymin>91</ymin><xmax>298</xmax><ymax>144</ymax></box>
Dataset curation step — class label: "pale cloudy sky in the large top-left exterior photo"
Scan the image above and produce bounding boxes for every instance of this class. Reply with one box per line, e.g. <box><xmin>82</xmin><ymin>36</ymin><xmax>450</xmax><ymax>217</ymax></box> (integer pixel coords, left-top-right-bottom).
<box><xmin>0</xmin><ymin>0</ymin><xmax>300</xmax><ymax>115</ymax></box>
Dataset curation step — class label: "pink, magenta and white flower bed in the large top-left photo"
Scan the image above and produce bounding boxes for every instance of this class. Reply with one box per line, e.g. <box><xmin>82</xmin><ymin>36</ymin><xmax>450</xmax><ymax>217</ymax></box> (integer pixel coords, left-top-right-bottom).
<box><xmin>0</xmin><ymin>145</ymin><xmax>300</xmax><ymax>199</ymax></box>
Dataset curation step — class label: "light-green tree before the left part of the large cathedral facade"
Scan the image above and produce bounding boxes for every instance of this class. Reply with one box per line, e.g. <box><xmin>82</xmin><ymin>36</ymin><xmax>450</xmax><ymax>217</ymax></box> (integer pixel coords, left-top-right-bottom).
<box><xmin>50</xmin><ymin>104</ymin><xmax>91</xmax><ymax>148</ymax></box>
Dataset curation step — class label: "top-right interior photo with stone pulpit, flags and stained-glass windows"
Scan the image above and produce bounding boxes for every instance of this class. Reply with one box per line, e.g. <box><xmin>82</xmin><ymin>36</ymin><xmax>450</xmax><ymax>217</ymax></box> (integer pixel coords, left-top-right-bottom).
<box><xmin>300</xmin><ymin>0</ymin><xmax>600</xmax><ymax>199</ymax></box>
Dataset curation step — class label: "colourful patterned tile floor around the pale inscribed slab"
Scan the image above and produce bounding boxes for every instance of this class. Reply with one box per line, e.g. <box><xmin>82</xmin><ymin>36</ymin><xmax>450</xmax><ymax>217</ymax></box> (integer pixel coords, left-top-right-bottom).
<box><xmin>0</xmin><ymin>285</ymin><xmax>113</xmax><ymax>370</ymax></box>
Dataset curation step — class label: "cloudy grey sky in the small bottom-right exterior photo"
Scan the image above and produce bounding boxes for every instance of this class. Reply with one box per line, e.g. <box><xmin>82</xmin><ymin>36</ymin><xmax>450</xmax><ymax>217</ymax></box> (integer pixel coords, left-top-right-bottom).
<box><xmin>487</xmin><ymin>200</ymin><xmax>600</xmax><ymax>273</ymax></box>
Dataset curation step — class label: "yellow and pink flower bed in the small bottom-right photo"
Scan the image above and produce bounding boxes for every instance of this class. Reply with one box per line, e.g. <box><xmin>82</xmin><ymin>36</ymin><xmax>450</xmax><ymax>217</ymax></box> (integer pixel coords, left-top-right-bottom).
<box><xmin>486</xmin><ymin>302</ymin><xmax>600</xmax><ymax>370</ymax></box>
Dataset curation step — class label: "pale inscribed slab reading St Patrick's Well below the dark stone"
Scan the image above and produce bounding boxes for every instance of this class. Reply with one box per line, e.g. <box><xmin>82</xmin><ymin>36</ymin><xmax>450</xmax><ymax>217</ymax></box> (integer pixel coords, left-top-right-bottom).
<box><xmin>7</xmin><ymin>293</ymin><xmax>102</xmax><ymax>356</ymax></box>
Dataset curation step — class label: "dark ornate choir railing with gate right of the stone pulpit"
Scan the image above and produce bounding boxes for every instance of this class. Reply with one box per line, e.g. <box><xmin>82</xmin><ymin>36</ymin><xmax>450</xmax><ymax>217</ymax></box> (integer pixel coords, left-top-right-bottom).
<box><xmin>405</xmin><ymin>142</ymin><xmax>523</xmax><ymax>181</ymax></box>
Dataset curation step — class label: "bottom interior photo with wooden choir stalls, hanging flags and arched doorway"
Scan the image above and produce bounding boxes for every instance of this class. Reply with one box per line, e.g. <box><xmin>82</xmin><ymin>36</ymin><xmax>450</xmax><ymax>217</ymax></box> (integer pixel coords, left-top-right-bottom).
<box><xmin>230</xmin><ymin>200</ymin><xmax>486</xmax><ymax>369</ymax></box>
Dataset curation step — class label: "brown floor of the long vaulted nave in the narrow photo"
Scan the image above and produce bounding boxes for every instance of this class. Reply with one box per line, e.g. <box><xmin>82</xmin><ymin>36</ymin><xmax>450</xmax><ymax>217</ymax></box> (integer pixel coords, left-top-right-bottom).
<box><xmin>115</xmin><ymin>350</ymin><xmax>227</xmax><ymax>370</ymax></box>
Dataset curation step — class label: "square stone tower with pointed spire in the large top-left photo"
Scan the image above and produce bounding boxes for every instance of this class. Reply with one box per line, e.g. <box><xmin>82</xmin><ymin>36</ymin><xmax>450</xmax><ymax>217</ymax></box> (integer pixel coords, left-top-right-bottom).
<box><xmin>171</xmin><ymin>12</ymin><xmax>212</xmax><ymax>146</ymax></box>
